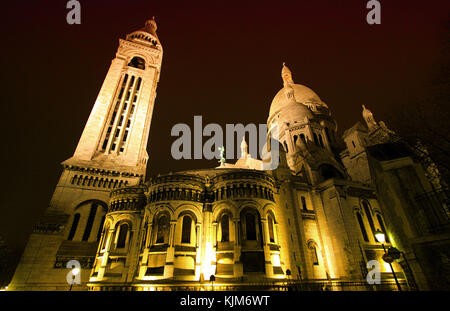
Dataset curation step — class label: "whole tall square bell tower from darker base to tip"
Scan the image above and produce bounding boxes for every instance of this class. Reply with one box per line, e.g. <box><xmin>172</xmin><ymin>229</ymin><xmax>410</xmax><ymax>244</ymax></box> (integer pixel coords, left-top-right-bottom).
<box><xmin>9</xmin><ymin>18</ymin><xmax>163</xmax><ymax>290</ymax></box>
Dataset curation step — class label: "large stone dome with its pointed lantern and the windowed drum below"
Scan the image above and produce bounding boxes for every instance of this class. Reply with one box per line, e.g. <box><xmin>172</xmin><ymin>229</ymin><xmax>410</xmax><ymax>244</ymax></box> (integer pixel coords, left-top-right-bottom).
<box><xmin>267</xmin><ymin>63</ymin><xmax>344</xmax><ymax>184</ymax></box>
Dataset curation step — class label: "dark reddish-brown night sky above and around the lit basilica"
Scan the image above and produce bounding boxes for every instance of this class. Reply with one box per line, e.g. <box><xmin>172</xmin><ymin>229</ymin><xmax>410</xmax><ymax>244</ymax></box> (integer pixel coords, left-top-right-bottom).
<box><xmin>0</xmin><ymin>0</ymin><xmax>450</xmax><ymax>276</ymax></box>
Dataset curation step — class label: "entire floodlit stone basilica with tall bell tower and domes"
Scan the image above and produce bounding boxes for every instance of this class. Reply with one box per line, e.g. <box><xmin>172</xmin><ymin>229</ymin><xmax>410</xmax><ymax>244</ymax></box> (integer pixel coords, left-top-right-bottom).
<box><xmin>8</xmin><ymin>19</ymin><xmax>449</xmax><ymax>291</ymax></box>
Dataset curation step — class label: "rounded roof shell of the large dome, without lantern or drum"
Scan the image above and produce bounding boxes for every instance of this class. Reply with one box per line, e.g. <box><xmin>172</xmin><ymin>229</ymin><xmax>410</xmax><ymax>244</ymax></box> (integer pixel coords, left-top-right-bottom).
<box><xmin>269</xmin><ymin>84</ymin><xmax>325</xmax><ymax>117</ymax></box>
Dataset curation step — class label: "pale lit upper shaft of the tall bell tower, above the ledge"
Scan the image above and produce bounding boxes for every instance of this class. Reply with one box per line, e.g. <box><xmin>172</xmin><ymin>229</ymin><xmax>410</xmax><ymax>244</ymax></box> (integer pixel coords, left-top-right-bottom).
<box><xmin>63</xmin><ymin>19</ymin><xmax>163</xmax><ymax>177</ymax></box>
